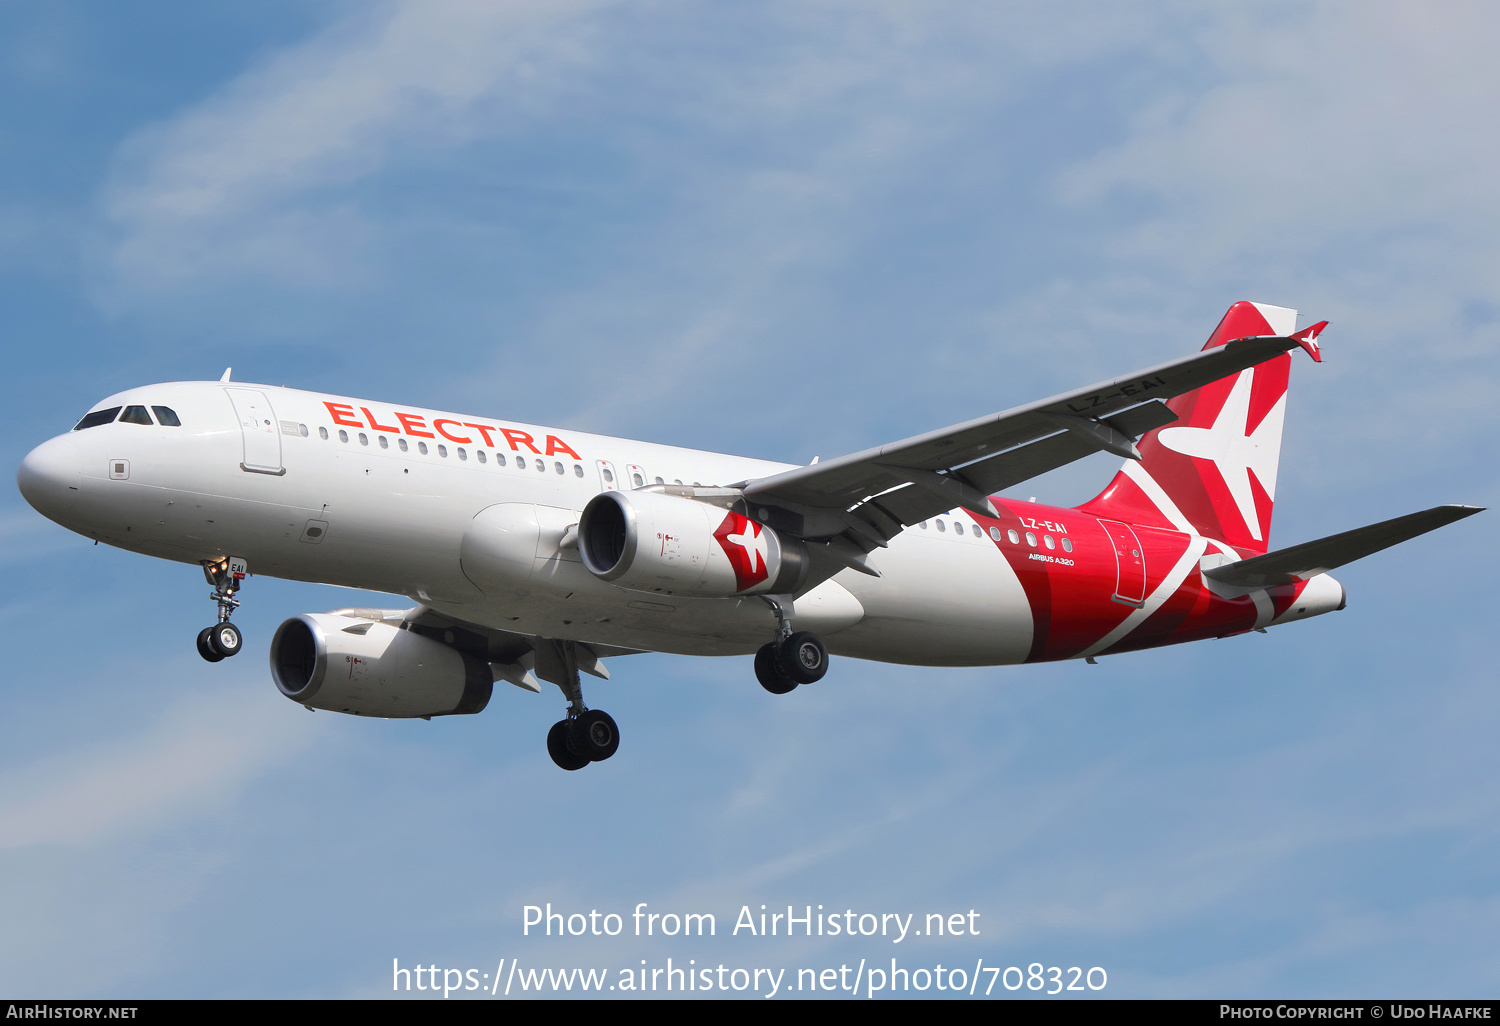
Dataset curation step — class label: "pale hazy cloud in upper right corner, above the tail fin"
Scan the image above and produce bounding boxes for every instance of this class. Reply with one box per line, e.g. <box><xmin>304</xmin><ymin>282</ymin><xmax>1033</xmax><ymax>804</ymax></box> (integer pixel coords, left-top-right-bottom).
<box><xmin>1061</xmin><ymin>2</ymin><xmax>1500</xmax><ymax>324</ymax></box>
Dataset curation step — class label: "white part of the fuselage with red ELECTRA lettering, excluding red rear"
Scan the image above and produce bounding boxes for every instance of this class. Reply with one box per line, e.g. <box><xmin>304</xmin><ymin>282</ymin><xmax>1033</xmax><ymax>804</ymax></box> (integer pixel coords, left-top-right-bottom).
<box><xmin>20</xmin><ymin>383</ymin><xmax>1032</xmax><ymax>665</ymax></box>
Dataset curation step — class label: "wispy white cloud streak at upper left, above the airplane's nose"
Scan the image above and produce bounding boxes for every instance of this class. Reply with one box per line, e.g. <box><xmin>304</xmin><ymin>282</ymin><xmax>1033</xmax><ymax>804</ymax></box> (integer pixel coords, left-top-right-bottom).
<box><xmin>105</xmin><ymin>0</ymin><xmax>599</xmax><ymax>288</ymax></box>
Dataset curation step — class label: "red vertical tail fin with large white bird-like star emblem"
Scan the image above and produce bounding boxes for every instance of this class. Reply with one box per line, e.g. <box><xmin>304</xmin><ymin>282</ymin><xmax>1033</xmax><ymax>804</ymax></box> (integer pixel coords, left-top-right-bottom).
<box><xmin>1079</xmin><ymin>303</ymin><xmax>1298</xmax><ymax>552</ymax></box>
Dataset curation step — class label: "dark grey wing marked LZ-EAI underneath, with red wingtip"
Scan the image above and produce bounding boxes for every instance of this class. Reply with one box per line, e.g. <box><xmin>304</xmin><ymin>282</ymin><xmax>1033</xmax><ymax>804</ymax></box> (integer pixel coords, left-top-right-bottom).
<box><xmin>734</xmin><ymin>324</ymin><xmax>1323</xmax><ymax>558</ymax></box>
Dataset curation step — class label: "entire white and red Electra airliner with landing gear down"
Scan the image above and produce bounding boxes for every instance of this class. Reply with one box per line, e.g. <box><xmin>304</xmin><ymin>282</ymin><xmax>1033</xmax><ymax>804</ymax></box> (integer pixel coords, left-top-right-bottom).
<box><xmin>17</xmin><ymin>302</ymin><xmax>1481</xmax><ymax>770</ymax></box>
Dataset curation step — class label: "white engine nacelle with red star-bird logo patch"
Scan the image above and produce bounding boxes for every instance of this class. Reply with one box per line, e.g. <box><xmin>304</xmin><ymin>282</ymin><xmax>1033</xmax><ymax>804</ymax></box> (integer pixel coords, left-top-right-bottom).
<box><xmin>578</xmin><ymin>492</ymin><xmax>807</xmax><ymax>599</ymax></box>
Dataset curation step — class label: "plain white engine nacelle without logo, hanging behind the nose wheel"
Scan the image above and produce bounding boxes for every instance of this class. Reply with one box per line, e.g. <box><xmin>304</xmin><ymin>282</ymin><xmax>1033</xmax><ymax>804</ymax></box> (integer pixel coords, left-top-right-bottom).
<box><xmin>272</xmin><ymin>614</ymin><xmax>495</xmax><ymax>720</ymax></box>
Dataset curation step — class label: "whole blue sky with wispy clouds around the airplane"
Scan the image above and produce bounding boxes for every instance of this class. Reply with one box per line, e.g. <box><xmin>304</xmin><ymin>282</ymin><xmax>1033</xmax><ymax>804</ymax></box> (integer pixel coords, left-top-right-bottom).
<box><xmin>0</xmin><ymin>0</ymin><xmax>1500</xmax><ymax>998</ymax></box>
